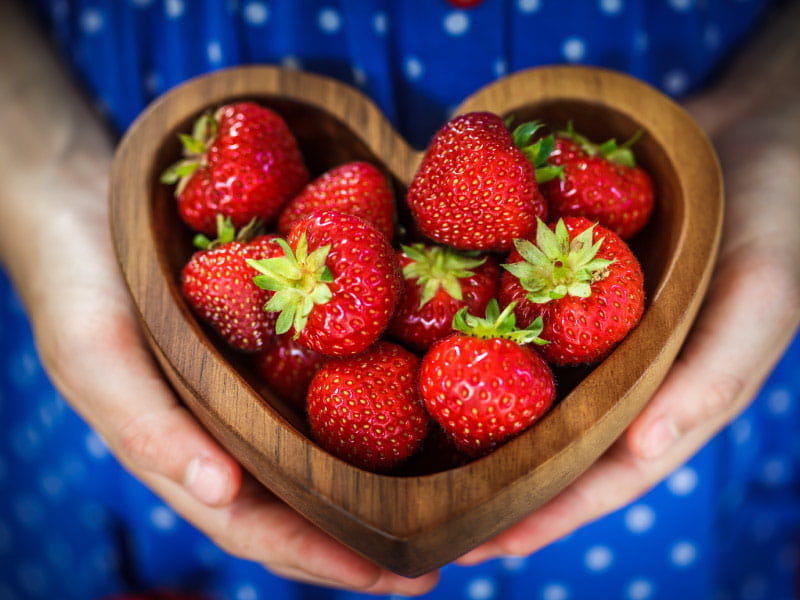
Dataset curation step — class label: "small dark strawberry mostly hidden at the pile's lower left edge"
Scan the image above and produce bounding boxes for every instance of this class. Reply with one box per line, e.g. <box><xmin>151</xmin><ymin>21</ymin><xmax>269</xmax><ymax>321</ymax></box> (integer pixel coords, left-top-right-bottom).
<box><xmin>253</xmin><ymin>333</ymin><xmax>326</xmax><ymax>409</ymax></box>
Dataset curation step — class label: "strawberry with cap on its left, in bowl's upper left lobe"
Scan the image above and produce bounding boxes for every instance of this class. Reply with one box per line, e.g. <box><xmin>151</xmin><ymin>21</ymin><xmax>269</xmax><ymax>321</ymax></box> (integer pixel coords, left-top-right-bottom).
<box><xmin>161</xmin><ymin>102</ymin><xmax>309</xmax><ymax>234</ymax></box>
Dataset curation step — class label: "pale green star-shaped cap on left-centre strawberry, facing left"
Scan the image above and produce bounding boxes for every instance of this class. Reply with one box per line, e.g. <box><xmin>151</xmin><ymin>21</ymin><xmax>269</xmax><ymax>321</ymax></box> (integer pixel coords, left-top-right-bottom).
<box><xmin>247</xmin><ymin>235</ymin><xmax>333</xmax><ymax>339</ymax></box>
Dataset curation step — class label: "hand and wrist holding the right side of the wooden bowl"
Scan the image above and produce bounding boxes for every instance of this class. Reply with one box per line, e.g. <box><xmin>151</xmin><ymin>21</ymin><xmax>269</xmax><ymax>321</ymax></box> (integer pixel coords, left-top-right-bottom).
<box><xmin>458</xmin><ymin>68</ymin><xmax>800</xmax><ymax>564</ymax></box>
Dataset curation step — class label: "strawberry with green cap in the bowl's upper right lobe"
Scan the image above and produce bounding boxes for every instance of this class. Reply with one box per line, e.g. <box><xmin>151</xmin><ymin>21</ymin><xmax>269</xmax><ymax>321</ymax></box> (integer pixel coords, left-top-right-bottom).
<box><xmin>542</xmin><ymin>123</ymin><xmax>655</xmax><ymax>240</ymax></box>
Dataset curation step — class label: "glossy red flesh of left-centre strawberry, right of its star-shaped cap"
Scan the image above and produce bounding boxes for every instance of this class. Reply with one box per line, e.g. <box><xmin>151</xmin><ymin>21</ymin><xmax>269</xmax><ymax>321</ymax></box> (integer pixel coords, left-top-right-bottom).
<box><xmin>287</xmin><ymin>211</ymin><xmax>403</xmax><ymax>356</ymax></box>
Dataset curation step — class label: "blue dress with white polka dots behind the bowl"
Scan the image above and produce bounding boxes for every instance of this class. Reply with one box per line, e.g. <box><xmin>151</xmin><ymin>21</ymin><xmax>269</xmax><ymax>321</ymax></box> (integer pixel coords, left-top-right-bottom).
<box><xmin>0</xmin><ymin>0</ymin><xmax>800</xmax><ymax>600</ymax></box>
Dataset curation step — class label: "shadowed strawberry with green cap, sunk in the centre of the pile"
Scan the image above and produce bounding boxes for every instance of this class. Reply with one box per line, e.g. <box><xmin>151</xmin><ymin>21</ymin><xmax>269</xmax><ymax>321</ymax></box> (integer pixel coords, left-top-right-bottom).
<box><xmin>387</xmin><ymin>244</ymin><xmax>500</xmax><ymax>351</ymax></box>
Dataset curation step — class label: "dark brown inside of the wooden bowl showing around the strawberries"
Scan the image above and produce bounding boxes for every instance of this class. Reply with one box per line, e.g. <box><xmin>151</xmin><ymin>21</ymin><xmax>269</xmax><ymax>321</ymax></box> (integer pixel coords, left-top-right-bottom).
<box><xmin>150</xmin><ymin>95</ymin><xmax>686</xmax><ymax>477</ymax></box>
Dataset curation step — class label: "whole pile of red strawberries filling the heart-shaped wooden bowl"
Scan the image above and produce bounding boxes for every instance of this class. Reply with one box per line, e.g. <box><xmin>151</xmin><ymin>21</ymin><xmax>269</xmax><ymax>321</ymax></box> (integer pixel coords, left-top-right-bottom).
<box><xmin>162</xmin><ymin>102</ymin><xmax>653</xmax><ymax>472</ymax></box>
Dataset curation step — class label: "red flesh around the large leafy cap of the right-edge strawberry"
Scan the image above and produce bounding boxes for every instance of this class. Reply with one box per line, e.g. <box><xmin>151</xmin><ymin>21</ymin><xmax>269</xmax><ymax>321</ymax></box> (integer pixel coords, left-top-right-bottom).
<box><xmin>498</xmin><ymin>217</ymin><xmax>644</xmax><ymax>365</ymax></box>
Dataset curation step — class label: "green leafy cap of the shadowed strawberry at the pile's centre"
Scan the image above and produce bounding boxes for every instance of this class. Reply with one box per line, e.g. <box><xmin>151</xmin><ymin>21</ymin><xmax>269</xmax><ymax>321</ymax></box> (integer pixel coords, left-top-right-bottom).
<box><xmin>401</xmin><ymin>244</ymin><xmax>486</xmax><ymax>308</ymax></box>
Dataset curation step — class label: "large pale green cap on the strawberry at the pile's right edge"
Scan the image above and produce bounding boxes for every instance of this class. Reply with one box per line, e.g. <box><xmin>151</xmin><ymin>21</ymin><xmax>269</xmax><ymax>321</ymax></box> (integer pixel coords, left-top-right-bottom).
<box><xmin>502</xmin><ymin>219</ymin><xmax>614</xmax><ymax>304</ymax></box>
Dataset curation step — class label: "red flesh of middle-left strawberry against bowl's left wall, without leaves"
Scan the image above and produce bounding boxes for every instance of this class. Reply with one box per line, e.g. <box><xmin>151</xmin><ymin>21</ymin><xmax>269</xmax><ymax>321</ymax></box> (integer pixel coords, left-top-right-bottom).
<box><xmin>182</xmin><ymin>235</ymin><xmax>283</xmax><ymax>352</ymax></box>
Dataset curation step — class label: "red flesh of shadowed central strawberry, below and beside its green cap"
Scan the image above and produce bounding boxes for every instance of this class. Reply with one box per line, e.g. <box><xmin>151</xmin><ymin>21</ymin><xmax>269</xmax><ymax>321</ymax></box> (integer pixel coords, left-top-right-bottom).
<box><xmin>387</xmin><ymin>250</ymin><xmax>500</xmax><ymax>352</ymax></box>
